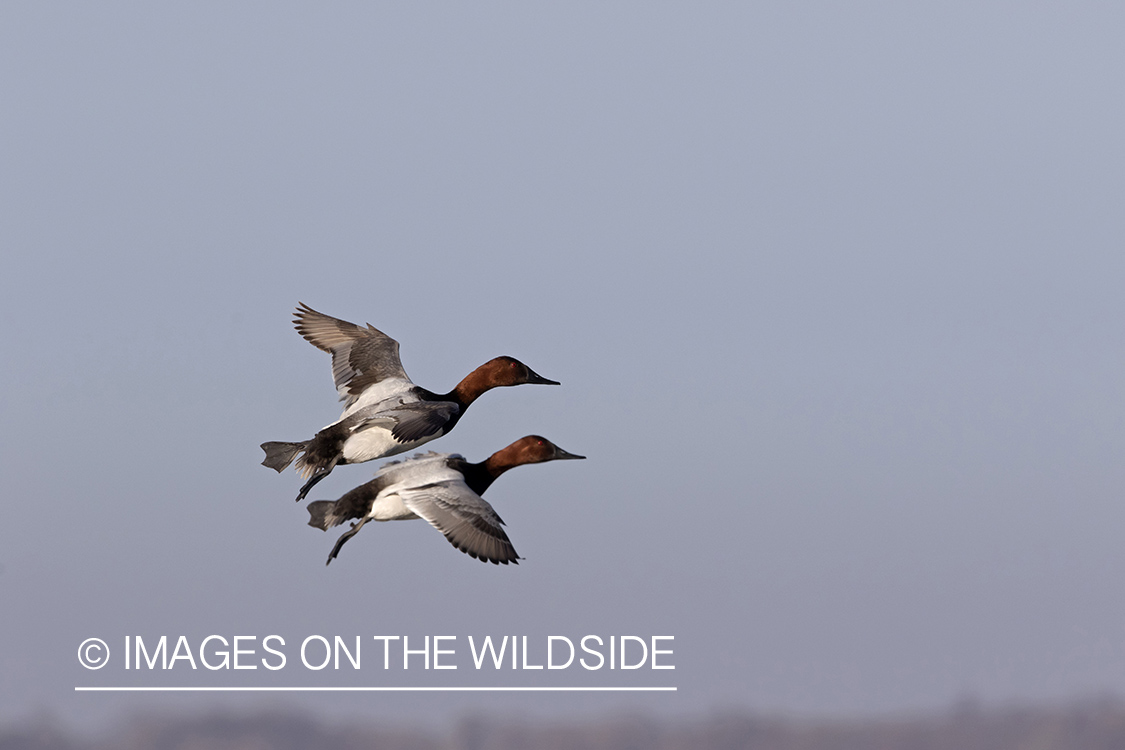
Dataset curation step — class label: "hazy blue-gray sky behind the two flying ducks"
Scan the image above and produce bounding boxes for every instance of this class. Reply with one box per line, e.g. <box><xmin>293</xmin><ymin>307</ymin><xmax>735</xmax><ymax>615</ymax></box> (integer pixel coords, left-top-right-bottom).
<box><xmin>0</xmin><ymin>2</ymin><xmax>1125</xmax><ymax>737</ymax></box>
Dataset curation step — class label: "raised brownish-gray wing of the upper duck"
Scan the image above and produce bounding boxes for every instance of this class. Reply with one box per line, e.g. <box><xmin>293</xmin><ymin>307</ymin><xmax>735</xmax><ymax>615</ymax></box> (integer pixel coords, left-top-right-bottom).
<box><xmin>294</xmin><ymin>302</ymin><xmax>410</xmax><ymax>406</ymax></box>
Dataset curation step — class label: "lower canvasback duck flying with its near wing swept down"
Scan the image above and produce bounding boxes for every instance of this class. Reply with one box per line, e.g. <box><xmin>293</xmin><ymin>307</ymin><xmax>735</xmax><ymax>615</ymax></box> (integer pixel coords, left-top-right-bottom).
<box><xmin>308</xmin><ymin>435</ymin><xmax>586</xmax><ymax>564</ymax></box>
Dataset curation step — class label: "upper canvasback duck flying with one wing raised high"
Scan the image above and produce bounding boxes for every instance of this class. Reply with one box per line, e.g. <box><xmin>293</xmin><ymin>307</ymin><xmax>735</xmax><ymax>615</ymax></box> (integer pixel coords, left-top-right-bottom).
<box><xmin>262</xmin><ymin>302</ymin><xmax>559</xmax><ymax>501</ymax></box>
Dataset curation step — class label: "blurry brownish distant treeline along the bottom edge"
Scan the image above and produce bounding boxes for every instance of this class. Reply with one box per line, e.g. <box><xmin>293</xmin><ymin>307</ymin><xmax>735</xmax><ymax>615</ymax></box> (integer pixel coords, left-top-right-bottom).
<box><xmin>0</xmin><ymin>701</ymin><xmax>1125</xmax><ymax>750</ymax></box>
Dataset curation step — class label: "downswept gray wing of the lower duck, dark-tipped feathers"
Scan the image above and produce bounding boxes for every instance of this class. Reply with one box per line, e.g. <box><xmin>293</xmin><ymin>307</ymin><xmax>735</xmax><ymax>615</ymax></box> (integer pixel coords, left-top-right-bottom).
<box><xmin>398</xmin><ymin>481</ymin><xmax>520</xmax><ymax>564</ymax></box>
